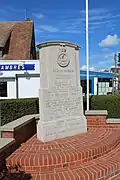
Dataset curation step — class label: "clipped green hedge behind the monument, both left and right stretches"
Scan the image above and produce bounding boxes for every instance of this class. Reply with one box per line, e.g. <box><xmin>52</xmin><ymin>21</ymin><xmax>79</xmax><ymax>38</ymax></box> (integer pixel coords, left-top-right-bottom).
<box><xmin>0</xmin><ymin>95</ymin><xmax>120</xmax><ymax>125</ymax></box>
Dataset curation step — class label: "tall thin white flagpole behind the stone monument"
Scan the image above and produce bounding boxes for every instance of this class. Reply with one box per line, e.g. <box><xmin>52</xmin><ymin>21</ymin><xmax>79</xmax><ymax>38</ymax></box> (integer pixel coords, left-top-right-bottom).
<box><xmin>86</xmin><ymin>0</ymin><xmax>89</xmax><ymax>110</ymax></box>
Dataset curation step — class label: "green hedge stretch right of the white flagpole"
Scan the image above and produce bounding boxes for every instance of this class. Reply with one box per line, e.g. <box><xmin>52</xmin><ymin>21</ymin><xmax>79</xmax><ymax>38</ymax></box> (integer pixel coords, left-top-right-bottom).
<box><xmin>91</xmin><ymin>95</ymin><xmax>120</xmax><ymax>118</ymax></box>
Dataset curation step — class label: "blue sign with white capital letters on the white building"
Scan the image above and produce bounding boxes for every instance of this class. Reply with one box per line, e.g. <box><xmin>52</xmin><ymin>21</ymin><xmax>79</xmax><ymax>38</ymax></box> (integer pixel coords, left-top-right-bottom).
<box><xmin>0</xmin><ymin>64</ymin><xmax>35</xmax><ymax>71</ymax></box>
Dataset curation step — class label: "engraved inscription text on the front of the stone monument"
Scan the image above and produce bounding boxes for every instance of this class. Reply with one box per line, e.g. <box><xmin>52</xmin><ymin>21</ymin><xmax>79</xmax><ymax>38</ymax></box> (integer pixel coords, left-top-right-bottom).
<box><xmin>44</xmin><ymin>69</ymin><xmax>82</xmax><ymax>121</ymax></box>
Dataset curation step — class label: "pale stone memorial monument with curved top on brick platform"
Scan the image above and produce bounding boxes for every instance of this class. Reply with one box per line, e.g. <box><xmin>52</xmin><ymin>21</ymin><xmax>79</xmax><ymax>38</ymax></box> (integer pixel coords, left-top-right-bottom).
<box><xmin>37</xmin><ymin>42</ymin><xmax>87</xmax><ymax>142</ymax></box>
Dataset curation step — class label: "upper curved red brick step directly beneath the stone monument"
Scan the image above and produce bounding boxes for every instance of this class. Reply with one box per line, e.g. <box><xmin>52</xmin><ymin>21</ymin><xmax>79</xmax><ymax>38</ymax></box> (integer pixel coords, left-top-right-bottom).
<box><xmin>7</xmin><ymin>129</ymin><xmax>120</xmax><ymax>173</ymax></box>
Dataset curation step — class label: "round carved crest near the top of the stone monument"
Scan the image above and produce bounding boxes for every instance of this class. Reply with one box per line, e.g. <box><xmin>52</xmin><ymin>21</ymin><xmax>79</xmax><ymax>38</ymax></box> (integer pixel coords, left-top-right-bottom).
<box><xmin>57</xmin><ymin>46</ymin><xmax>70</xmax><ymax>68</ymax></box>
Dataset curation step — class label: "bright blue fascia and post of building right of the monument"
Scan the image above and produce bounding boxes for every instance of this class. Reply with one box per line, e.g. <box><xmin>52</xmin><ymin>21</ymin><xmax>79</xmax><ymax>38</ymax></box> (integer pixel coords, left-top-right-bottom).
<box><xmin>80</xmin><ymin>70</ymin><xmax>113</xmax><ymax>94</ymax></box>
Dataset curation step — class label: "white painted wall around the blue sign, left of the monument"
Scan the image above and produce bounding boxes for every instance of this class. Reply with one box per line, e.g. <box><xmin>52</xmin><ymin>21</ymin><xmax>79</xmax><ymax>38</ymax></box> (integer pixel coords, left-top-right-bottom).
<box><xmin>0</xmin><ymin>60</ymin><xmax>40</xmax><ymax>99</ymax></box>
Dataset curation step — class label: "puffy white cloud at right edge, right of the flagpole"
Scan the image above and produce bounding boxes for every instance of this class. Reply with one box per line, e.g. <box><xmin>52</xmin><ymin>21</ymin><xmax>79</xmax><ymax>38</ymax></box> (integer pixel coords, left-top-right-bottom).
<box><xmin>99</xmin><ymin>34</ymin><xmax>120</xmax><ymax>47</ymax></box>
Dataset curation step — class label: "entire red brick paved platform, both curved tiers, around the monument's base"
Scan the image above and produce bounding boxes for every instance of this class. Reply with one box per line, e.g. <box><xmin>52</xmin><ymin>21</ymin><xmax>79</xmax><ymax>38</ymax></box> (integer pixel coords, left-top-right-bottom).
<box><xmin>6</xmin><ymin>128</ymin><xmax>120</xmax><ymax>180</ymax></box>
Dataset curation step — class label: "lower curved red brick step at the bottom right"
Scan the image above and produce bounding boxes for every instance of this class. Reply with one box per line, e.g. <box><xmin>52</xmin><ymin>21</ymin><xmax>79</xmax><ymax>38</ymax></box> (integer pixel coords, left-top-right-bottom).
<box><xmin>32</xmin><ymin>145</ymin><xmax>120</xmax><ymax>180</ymax></box>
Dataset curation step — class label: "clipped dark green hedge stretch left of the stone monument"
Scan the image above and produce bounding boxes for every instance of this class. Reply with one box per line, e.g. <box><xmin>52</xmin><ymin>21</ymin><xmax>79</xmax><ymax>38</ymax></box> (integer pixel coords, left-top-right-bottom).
<box><xmin>0</xmin><ymin>98</ymin><xmax>39</xmax><ymax>125</ymax></box>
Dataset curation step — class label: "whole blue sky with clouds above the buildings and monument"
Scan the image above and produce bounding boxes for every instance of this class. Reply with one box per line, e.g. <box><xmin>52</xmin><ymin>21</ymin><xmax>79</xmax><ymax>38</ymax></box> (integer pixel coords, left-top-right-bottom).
<box><xmin>0</xmin><ymin>0</ymin><xmax>120</xmax><ymax>70</ymax></box>
